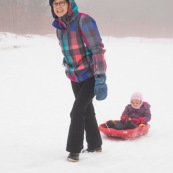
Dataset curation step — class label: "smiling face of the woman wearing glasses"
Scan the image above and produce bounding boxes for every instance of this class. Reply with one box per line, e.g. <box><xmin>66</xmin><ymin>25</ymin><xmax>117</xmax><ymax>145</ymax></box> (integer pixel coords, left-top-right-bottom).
<box><xmin>53</xmin><ymin>0</ymin><xmax>69</xmax><ymax>17</ymax></box>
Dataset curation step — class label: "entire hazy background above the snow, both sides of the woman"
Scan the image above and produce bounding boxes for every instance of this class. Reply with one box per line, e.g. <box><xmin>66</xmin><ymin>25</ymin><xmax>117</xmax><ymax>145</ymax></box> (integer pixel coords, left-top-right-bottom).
<box><xmin>0</xmin><ymin>0</ymin><xmax>173</xmax><ymax>38</ymax></box>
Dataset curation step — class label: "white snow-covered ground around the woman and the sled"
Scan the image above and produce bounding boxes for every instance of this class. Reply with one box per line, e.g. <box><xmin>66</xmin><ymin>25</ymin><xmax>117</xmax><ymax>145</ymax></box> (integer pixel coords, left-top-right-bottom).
<box><xmin>0</xmin><ymin>33</ymin><xmax>173</xmax><ymax>173</ymax></box>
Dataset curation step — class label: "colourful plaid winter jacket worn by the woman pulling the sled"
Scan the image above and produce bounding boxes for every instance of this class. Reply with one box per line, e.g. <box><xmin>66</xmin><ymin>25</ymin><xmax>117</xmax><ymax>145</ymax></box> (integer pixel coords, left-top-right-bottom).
<box><xmin>53</xmin><ymin>0</ymin><xmax>106</xmax><ymax>82</ymax></box>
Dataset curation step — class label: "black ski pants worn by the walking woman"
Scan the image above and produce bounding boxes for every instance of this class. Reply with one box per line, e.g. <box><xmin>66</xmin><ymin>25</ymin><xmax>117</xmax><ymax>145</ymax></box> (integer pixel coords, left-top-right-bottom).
<box><xmin>66</xmin><ymin>77</ymin><xmax>102</xmax><ymax>153</ymax></box>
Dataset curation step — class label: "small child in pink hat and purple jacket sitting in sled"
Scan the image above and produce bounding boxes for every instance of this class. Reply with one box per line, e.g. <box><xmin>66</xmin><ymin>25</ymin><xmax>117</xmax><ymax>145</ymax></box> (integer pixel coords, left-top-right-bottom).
<box><xmin>106</xmin><ymin>92</ymin><xmax>151</xmax><ymax>130</ymax></box>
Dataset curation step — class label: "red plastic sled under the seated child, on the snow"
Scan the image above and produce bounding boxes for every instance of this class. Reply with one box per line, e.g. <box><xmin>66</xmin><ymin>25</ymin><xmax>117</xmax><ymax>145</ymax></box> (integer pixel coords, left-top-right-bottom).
<box><xmin>99</xmin><ymin>123</ymin><xmax>150</xmax><ymax>139</ymax></box>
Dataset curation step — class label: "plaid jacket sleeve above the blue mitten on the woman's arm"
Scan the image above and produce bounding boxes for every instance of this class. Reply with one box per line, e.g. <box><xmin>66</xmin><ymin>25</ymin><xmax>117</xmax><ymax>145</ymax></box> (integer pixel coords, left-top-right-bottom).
<box><xmin>79</xmin><ymin>15</ymin><xmax>107</xmax><ymax>75</ymax></box>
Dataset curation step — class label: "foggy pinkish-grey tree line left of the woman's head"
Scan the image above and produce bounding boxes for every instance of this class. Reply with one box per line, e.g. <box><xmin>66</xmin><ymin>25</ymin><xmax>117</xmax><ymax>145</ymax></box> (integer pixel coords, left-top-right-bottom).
<box><xmin>0</xmin><ymin>0</ymin><xmax>51</xmax><ymax>34</ymax></box>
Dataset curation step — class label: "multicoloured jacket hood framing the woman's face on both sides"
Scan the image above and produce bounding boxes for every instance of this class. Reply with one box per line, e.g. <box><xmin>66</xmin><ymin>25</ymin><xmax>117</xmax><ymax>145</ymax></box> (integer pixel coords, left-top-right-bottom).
<box><xmin>49</xmin><ymin>0</ymin><xmax>78</xmax><ymax>19</ymax></box>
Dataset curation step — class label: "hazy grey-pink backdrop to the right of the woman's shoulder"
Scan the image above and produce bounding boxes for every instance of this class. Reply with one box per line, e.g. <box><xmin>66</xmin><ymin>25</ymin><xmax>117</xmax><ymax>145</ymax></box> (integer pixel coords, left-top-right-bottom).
<box><xmin>76</xmin><ymin>0</ymin><xmax>173</xmax><ymax>37</ymax></box>
